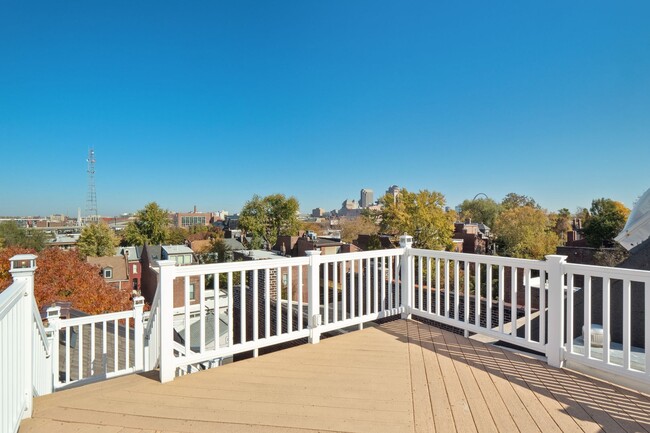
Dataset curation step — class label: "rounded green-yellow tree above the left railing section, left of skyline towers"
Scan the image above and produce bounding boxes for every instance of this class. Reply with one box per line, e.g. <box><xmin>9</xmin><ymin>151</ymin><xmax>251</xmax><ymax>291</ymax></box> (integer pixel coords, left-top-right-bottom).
<box><xmin>239</xmin><ymin>194</ymin><xmax>300</xmax><ymax>249</ymax></box>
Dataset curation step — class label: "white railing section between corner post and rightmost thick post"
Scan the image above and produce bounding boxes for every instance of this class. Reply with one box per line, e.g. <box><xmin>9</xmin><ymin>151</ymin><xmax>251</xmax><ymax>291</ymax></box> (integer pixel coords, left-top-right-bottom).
<box><xmin>405</xmin><ymin>249</ymin><xmax>549</xmax><ymax>353</ymax></box>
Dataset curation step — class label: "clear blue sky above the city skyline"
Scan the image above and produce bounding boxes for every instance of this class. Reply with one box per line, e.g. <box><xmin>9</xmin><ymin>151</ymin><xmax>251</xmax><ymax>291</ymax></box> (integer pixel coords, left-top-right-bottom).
<box><xmin>0</xmin><ymin>0</ymin><xmax>650</xmax><ymax>215</ymax></box>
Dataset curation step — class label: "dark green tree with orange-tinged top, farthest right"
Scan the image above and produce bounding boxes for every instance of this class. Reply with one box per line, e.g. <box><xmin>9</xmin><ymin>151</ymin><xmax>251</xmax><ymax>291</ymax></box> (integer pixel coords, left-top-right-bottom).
<box><xmin>582</xmin><ymin>198</ymin><xmax>630</xmax><ymax>248</ymax></box>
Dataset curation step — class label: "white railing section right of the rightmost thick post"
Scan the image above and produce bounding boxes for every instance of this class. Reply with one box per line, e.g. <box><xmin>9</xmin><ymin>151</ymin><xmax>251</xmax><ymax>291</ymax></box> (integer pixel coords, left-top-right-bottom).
<box><xmin>563</xmin><ymin>263</ymin><xmax>650</xmax><ymax>385</ymax></box>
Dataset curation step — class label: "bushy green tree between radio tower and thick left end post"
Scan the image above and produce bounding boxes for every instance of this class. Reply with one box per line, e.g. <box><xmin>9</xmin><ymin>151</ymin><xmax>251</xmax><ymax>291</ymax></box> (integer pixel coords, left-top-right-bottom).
<box><xmin>124</xmin><ymin>202</ymin><xmax>171</xmax><ymax>245</ymax></box>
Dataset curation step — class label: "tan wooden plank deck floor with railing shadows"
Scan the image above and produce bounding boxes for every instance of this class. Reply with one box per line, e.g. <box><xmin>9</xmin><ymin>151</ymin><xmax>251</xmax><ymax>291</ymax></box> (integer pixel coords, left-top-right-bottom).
<box><xmin>20</xmin><ymin>320</ymin><xmax>650</xmax><ymax>433</ymax></box>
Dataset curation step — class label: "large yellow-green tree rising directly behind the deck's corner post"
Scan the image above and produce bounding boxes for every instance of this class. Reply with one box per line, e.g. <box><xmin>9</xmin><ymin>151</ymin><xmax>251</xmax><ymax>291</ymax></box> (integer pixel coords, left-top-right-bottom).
<box><xmin>380</xmin><ymin>189</ymin><xmax>455</xmax><ymax>250</ymax></box>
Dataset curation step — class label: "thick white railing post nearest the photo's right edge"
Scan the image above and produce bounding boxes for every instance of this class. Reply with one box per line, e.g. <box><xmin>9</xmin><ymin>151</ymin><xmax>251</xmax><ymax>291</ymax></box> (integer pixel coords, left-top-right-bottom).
<box><xmin>539</xmin><ymin>255</ymin><xmax>572</xmax><ymax>367</ymax></box>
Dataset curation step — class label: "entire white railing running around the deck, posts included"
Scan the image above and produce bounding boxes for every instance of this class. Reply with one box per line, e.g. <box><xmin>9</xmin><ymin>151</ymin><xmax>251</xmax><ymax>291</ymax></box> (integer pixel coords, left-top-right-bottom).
<box><xmin>7</xmin><ymin>236</ymin><xmax>650</xmax><ymax>432</ymax></box>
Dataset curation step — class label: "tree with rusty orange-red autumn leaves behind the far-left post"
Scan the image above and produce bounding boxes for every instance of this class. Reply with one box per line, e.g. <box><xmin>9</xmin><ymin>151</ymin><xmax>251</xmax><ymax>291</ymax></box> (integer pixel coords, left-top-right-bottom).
<box><xmin>0</xmin><ymin>247</ymin><xmax>133</xmax><ymax>314</ymax></box>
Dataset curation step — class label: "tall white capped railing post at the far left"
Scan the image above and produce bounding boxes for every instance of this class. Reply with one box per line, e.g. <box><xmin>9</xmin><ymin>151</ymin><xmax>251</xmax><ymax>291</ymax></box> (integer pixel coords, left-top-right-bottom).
<box><xmin>9</xmin><ymin>254</ymin><xmax>36</xmax><ymax>419</ymax></box>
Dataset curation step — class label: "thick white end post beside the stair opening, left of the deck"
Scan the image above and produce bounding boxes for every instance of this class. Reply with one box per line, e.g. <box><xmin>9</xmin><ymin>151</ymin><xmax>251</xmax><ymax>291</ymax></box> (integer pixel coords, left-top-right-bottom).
<box><xmin>157</xmin><ymin>260</ymin><xmax>176</xmax><ymax>383</ymax></box>
